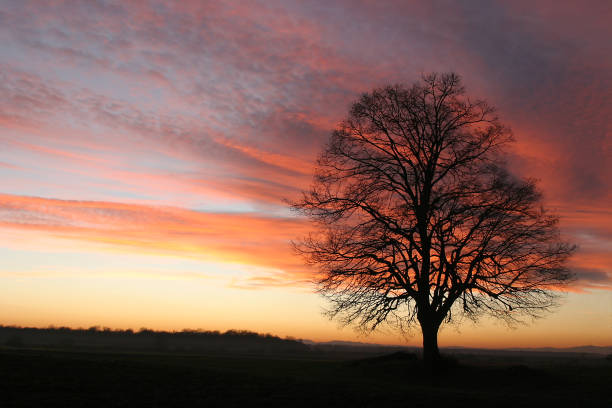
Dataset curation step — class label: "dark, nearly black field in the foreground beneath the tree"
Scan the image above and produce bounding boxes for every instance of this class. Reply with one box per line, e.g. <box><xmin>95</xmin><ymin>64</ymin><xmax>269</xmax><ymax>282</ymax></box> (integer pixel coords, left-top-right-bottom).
<box><xmin>0</xmin><ymin>347</ymin><xmax>612</xmax><ymax>408</ymax></box>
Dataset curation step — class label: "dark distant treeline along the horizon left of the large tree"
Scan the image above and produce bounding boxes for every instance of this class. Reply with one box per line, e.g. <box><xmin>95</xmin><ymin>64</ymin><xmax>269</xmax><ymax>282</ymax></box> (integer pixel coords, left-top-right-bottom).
<box><xmin>0</xmin><ymin>326</ymin><xmax>310</xmax><ymax>354</ymax></box>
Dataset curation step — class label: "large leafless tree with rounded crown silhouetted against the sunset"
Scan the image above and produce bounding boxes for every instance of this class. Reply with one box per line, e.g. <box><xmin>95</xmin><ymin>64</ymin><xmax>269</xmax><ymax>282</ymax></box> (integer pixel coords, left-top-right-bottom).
<box><xmin>293</xmin><ymin>73</ymin><xmax>574</xmax><ymax>367</ymax></box>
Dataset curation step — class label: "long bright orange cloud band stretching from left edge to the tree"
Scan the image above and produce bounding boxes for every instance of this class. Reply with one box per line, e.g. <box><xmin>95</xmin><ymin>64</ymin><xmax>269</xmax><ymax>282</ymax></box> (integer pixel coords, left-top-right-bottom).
<box><xmin>0</xmin><ymin>194</ymin><xmax>309</xmax><ymax>287</ymax></box>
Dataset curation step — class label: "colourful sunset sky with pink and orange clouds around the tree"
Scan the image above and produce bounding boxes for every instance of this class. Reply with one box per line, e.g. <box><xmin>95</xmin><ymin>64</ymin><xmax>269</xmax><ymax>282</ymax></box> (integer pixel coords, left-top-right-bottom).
<box><xmin>0</xmin><ymin>0</ymin><xmax>612</xmax><ymax>347</ymax></box>
